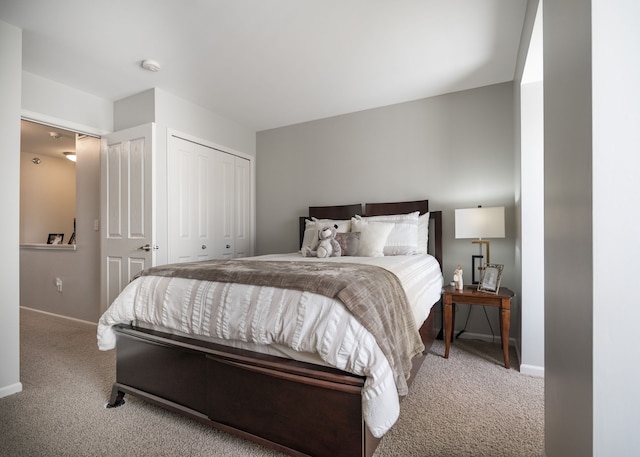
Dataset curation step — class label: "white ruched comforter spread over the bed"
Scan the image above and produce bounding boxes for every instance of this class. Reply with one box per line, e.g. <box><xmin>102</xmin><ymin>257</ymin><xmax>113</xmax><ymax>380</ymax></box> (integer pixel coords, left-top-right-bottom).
<box><xmin>98</xmin><ymin>253</ymin><xmax>442</xmax><ymax>437</ymax></box>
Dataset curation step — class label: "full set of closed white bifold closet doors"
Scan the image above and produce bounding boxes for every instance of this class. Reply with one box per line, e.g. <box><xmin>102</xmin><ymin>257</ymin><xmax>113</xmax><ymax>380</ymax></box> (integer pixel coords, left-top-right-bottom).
<box><xmin>167</xmin><ymin>135</ymin><xmax>251</xmax><ymax>263</ymax></box>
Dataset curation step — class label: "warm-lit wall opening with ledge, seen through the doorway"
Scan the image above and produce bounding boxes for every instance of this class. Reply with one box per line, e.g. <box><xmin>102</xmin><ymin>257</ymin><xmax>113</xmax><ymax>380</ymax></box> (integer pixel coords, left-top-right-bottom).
<box><xmin>20</xmin><ymin>120</ymin><xmax>77</xmax><ymax>245</ymax></box>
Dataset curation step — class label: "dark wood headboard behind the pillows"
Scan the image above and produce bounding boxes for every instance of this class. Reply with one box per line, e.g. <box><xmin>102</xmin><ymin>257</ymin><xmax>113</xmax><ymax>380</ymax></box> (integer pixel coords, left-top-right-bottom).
<box><xmin>300</xmin><ymin>200</ymin><xmax>442</xmax><ymax>269</ymax></box>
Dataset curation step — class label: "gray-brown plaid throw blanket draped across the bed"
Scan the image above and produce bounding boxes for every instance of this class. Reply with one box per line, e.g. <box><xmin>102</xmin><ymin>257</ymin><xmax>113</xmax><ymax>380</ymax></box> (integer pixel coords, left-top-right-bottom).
<box><xmin>139</xmin><ymin>259</ymin><xmax>424</xmax><ymax>395</ymax></box>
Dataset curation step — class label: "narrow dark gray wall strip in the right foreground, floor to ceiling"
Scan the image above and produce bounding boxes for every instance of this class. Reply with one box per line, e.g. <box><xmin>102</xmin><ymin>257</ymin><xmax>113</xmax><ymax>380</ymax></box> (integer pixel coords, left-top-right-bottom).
<box><xmin>544</xmin><ymin>1</ymin><xmax>592</xmax><ymax>457</ymax></box>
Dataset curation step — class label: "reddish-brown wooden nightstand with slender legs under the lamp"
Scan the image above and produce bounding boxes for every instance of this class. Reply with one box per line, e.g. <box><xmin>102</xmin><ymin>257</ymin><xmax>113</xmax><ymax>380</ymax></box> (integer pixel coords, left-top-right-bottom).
<box><xmin>442</xmin><ymin>286</ymin><xmax>514</xmax><ymax>368</ymax></box>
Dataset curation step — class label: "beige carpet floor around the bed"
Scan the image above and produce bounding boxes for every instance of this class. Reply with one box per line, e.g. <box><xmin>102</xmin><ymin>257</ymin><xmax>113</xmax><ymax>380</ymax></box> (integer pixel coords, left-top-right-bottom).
<box><xmin>0</xmin><ymin>309</ymin><xmax>544</xmax><ymax>457</ymax></box>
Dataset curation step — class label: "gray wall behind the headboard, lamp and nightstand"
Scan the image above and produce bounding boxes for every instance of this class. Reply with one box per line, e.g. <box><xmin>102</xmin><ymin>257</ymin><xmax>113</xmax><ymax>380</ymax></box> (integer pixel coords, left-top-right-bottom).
<box><xmin>256</xmin><ymin>83</ymin><xmax>519</xmax><ymax>335</ymax></box>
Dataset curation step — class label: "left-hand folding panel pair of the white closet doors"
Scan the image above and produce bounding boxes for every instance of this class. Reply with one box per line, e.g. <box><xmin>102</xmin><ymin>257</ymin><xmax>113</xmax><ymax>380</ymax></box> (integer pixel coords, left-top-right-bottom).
<box><xmin>167</xmin><ymin>135</ymin><xmax>217</xmax><ymax>263</ymax></box>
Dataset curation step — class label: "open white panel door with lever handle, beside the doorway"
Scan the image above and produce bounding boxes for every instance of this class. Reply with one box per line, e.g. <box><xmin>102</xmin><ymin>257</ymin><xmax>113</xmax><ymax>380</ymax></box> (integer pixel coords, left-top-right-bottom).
<box><xmin>100</xmin><ymin>123</ymin><xmax>155</xmax><ymax>311</ymax></box>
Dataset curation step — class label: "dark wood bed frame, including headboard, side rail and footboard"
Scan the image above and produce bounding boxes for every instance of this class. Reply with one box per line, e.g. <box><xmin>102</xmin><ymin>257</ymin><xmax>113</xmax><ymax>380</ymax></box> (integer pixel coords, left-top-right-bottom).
<box><xmin>107</xmin><ymin>200</ymin><xmax>442</xmax><ymax>457</ymax></box>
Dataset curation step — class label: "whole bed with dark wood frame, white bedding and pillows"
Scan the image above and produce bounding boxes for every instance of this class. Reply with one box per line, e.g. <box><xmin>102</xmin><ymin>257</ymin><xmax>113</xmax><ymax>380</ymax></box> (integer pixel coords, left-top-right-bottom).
<box><xmin>98</xmin><ymin>200</ymin><xmax>442</xmax><ymax>456</ymax></box>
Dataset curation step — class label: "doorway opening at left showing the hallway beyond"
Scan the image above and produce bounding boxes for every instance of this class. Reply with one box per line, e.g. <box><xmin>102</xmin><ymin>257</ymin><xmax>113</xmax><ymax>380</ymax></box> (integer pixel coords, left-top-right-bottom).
<box><xmin>20</xmin><ymin>119</ymin><xmax>100</xmax><ymax>323</ymax></box>
